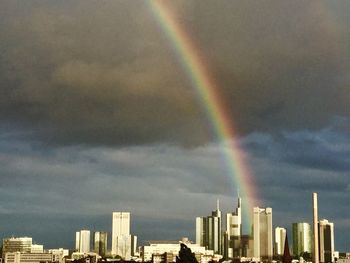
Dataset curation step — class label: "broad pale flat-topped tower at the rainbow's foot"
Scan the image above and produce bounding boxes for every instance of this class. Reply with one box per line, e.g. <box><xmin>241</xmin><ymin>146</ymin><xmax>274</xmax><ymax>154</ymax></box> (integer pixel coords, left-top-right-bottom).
<box><xmin>253</xmin><ymin>207</ymin><xmax>273</xmax><ymax>260</ymax></box>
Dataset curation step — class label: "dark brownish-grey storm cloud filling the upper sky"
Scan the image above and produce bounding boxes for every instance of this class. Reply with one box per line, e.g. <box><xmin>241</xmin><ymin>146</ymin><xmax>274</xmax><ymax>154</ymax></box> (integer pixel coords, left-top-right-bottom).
<box><xmin>0</xmin><ymin>1</ymin><xmax>349</xmax><ymax>144</ymax></box>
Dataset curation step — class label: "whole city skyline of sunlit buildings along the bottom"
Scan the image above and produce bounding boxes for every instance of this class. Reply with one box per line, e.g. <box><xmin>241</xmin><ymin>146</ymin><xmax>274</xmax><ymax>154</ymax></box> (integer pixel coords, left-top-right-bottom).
<box><xmin>0</xmin><ymin>193</ymin><xmax>344</xmax><ymax>263</ymax></box>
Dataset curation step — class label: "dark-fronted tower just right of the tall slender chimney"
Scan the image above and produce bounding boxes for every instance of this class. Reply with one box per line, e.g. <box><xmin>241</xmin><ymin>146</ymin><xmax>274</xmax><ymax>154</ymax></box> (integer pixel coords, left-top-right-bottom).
<box><xmin>319</xmin><ymin>219</ymin><xmax>334</xmax><ymax>263</ymax></box>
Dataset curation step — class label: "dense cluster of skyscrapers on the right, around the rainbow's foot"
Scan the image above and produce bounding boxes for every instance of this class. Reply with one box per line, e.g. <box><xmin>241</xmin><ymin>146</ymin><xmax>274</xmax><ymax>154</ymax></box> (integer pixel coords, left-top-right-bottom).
<box><xmin>196</xmin><ymin>194</ymin><xmax>339</xmax><ymax>263</ymax></box>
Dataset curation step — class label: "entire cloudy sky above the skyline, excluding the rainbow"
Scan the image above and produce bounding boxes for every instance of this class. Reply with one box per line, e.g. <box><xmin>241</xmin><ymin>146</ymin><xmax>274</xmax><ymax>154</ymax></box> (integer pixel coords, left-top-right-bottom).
<box><xmin>0</xmin><ymin>0</ymin><xmax>350</xmax><ymax>254</ymax></box>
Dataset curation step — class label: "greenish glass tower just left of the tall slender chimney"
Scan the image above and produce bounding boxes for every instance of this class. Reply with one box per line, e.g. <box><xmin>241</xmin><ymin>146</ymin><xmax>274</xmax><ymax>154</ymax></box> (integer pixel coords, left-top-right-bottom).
<box><xmin>292</xmin><ymin>223</ymin><xmax>312</xmax><ymax>257</ymax></box>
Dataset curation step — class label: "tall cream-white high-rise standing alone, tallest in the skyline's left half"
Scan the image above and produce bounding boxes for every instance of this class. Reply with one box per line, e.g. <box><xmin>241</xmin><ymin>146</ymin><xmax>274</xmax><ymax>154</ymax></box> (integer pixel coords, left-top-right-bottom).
<box><xmin>112</xmin><ymin>212</ymin><xmax>137</xmax><ymax>260</ymax></box>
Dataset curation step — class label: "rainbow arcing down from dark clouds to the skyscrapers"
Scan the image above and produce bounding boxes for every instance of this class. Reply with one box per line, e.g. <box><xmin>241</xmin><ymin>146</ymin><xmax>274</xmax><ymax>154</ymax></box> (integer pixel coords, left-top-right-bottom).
<box><xmin>147</xmin><ymin>0</ymin><xmax>258</xmax><ymax>224</ymax></box>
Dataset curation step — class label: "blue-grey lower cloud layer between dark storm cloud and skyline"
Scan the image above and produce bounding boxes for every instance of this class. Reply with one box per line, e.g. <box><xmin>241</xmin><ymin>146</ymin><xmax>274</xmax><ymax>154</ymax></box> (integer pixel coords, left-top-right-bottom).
<box><xmin>0</xmin><ymin>125</ymin><xmax>350</xmax><ymax>250</ymax></box>
